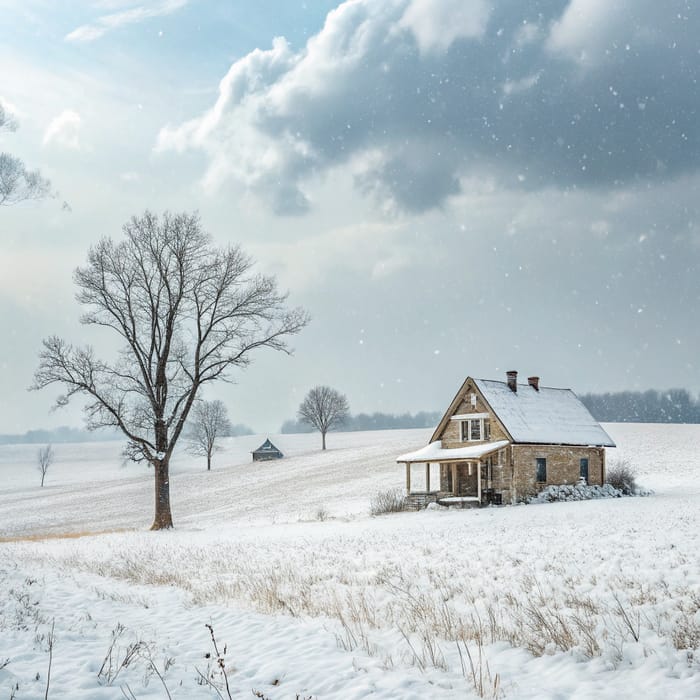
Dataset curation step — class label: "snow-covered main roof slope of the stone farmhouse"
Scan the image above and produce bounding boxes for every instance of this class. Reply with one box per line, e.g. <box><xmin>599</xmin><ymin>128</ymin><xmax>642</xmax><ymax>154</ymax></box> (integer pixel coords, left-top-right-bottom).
<box><xmin>474</xmin><ymin>379</ymin><xmax>615</xmax><ymax>447</ymax></box>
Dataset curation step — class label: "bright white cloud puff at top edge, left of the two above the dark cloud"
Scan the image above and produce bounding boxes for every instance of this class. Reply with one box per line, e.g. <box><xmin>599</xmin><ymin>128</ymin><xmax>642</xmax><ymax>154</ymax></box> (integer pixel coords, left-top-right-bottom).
<box><xmin>399</xmin><ymin>0</ymin><xmax>491</xmax><ymax>53</ymax></box>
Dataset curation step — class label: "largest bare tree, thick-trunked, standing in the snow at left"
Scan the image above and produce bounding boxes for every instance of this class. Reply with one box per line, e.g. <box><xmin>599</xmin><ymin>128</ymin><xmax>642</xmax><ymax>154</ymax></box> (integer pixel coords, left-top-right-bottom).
<box><xmin>32</xmin><ymin>212</ymin><xmax>308</xmax><ymax>529</ymax></box>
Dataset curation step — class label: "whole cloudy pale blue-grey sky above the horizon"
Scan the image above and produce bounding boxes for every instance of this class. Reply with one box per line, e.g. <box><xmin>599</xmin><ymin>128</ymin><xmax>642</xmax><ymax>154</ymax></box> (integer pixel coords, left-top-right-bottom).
<box><xmin>0</xmin><ymin>0</ymin><xmax>700</xmax><ymax>433</ymax></box>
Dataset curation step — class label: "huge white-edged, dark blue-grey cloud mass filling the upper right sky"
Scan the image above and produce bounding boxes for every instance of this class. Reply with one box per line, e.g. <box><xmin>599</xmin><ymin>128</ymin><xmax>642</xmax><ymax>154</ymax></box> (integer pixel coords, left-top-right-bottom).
<box><xmin>155</xmin><ymin>0</ymin><xmax>697</xmax><ymax>214</ymax></box>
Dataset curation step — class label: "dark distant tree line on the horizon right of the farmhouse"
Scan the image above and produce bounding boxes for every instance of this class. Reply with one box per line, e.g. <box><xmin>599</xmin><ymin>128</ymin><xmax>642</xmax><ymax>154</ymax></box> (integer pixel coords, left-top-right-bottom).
<box><xmin>580</xmin><ymin>389</ymin><xmax>700</xmax><ymax>423</ymax></box>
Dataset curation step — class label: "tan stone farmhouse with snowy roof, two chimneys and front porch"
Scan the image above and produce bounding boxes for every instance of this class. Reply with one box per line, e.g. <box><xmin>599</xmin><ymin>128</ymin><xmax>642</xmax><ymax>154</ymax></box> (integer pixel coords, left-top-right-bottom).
<box><xmin>396</xmin><ymin>371</ymin><xmax>615</xmax><ymax>507</ymax></box>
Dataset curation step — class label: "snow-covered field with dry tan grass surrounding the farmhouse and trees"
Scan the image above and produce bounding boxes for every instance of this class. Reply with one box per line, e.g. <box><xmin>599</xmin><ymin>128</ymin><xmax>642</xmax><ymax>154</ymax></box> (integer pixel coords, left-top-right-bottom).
<box><xmin>0</xmin><ymin>424</ymin><xmax>700</xmax><ymax>700</ymax></box>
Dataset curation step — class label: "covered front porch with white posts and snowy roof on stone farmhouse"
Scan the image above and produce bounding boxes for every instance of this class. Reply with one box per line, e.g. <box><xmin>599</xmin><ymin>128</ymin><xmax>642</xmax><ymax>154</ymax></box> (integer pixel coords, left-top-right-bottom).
<box><xmin>397</xmin><ymin>440</ymin><xmax>508</xmax><ymax>507</ymax></box>
